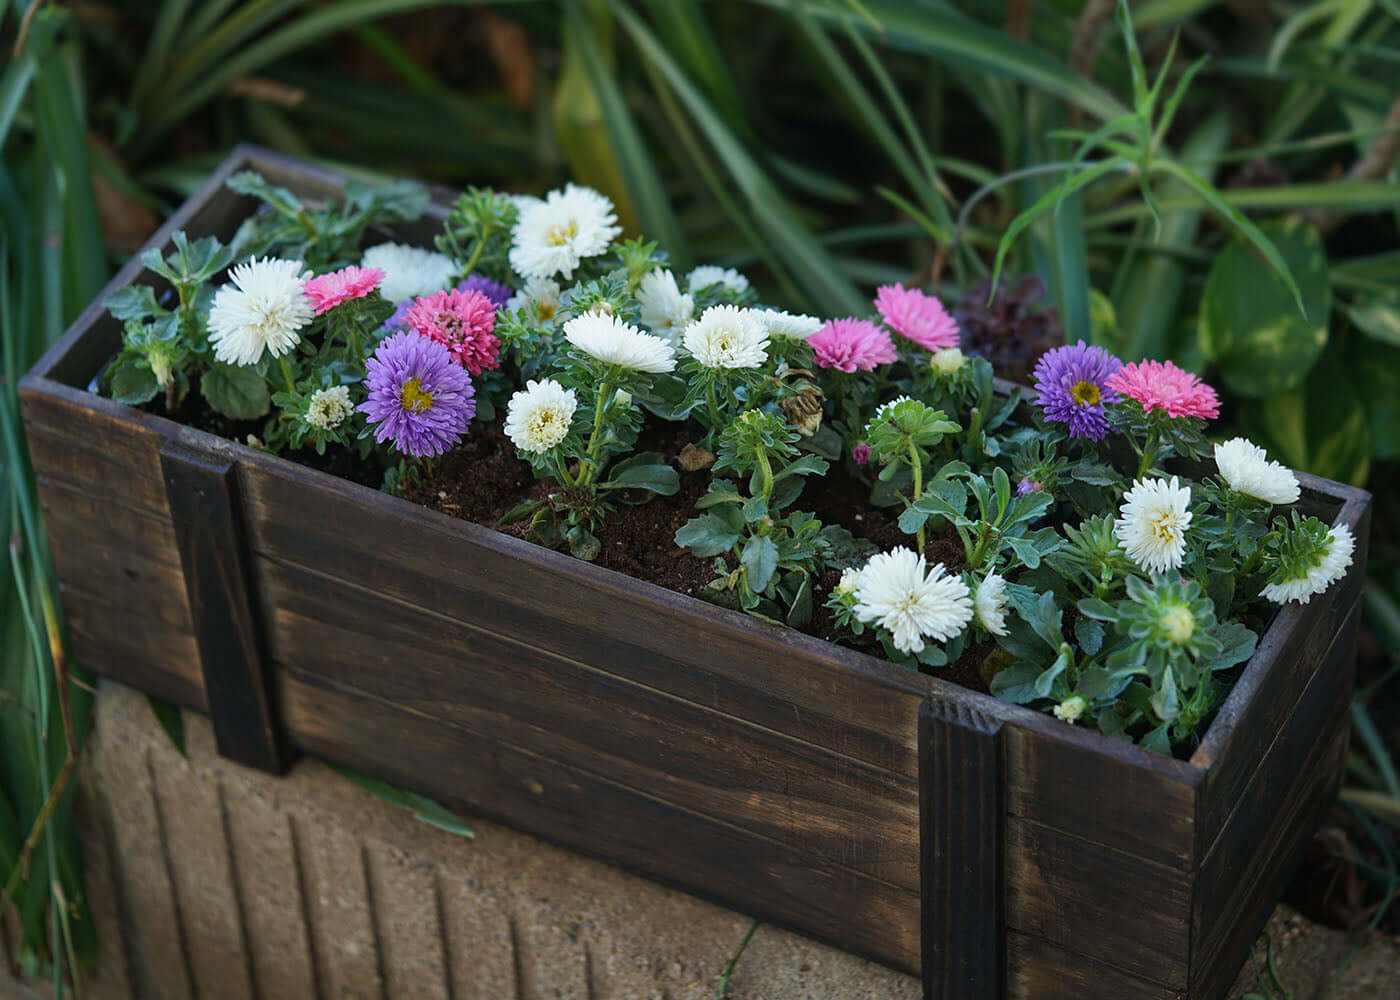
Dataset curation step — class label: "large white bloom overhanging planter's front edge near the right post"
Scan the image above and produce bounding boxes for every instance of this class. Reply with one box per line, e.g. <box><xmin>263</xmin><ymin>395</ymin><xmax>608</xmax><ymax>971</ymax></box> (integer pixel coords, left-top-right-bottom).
<box><xmin>855</xmin><ymin>548</ymin><xmax>973</xmax><ymax>653</ymax></box>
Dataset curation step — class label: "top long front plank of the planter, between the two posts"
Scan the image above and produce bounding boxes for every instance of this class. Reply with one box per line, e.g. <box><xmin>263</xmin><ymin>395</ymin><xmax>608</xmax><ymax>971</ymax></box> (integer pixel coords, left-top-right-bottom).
<box><xmin>245</xmin><ymin>452</ymin><xmax>974</xmax><ymax>779</ymax></box>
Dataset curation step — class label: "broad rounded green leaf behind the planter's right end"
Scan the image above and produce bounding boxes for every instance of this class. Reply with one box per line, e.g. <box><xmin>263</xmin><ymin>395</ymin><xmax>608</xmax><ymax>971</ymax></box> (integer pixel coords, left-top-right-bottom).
<box><xmin>1197</xmin><ymin>218</ymin><xmax>1331</xmax><ymax>399</ymax></box>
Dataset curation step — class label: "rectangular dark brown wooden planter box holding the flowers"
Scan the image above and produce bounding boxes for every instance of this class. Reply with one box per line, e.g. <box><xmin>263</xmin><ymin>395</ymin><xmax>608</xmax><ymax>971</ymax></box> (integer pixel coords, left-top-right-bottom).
<box><xmin>21</xmin><ymin>147</ymin><xmax>1371</xmax><ymax>1000</ymax></box>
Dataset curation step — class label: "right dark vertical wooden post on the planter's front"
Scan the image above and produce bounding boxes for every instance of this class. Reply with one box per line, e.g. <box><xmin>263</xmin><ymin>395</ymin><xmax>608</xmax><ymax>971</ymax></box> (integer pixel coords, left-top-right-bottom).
<box><xmin>918</xmin><ymin>697</ymin><xmax>1007</xmax><ymax>1000</ymax></box>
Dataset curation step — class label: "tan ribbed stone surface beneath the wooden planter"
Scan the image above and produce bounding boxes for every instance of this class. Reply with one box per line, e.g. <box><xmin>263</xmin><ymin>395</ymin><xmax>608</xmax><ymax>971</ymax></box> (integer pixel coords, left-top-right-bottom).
<box><xmin>0</xmin><ymin>683</ymin><xmax>1400</xmax><ymax>1000</ymax></box>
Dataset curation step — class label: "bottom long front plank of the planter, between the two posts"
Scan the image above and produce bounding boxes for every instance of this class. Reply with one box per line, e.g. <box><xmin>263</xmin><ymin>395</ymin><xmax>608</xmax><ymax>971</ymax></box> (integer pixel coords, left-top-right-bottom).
<box><xmin>277</xmin><ymin>669</ymin><xmax>918</xmax><ymax>975</ymax></box>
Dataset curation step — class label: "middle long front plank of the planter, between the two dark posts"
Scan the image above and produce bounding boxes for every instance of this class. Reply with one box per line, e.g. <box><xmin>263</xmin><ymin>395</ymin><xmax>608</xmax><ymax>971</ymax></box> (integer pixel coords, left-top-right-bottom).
<box><xmin>258</xmin><ymin>559</ymin><xmax>920</xmax><ymax>891</ymax></box>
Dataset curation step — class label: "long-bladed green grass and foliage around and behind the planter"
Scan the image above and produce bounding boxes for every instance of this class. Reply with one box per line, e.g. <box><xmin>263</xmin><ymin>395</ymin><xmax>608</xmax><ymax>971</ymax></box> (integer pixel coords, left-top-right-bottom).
<box><xmin>0</xmin><ymin>0</ymin><xmax>1400</xmax><ymax>990</ymax></box>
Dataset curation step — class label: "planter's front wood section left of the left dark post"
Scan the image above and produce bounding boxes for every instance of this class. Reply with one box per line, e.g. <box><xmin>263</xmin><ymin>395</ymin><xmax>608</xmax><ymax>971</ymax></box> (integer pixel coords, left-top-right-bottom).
<box><xmin>21</xmin><ymin>380</ymin><xmax>209</xmax><ymax>711</ymax></box>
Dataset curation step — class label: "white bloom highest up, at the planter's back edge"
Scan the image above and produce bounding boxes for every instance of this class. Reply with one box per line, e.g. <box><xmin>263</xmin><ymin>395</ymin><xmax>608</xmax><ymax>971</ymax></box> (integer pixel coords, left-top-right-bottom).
<box><xmin>510</xmin><ymin>183</ymin><xmax>622</xmax><ymax>279</ymax></box>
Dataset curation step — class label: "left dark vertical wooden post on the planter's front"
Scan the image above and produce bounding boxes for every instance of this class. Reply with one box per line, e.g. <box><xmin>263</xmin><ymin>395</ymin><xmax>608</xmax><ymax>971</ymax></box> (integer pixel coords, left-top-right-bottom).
<box><xmin>161</xmin><ymin>438</ymin><xmax>290</xmax><ymax>775</ymax></box>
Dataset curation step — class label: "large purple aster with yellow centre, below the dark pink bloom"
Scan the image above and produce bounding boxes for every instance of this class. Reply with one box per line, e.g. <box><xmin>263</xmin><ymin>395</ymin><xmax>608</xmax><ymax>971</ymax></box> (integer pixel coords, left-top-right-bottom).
<box><xmin>357</xmin><ymin>331</ymin><xmax>476</xmax><ymax>458</ymax></box>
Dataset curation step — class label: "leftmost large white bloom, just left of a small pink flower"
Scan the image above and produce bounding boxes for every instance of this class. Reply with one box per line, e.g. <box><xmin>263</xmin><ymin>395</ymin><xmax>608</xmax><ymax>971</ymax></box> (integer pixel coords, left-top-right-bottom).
<box><xmin>209</xmin><ymin>258</ymin><xmax>315</xmax><ymax>364</ymax></box>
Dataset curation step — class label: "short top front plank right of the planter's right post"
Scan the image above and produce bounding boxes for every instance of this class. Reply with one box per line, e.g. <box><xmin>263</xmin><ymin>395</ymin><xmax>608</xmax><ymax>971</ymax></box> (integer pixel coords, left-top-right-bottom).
<box><xmin>1007</xmin><ymin>713</ymin><xmax>1204</xmax><ymax>871</ymax></box>
